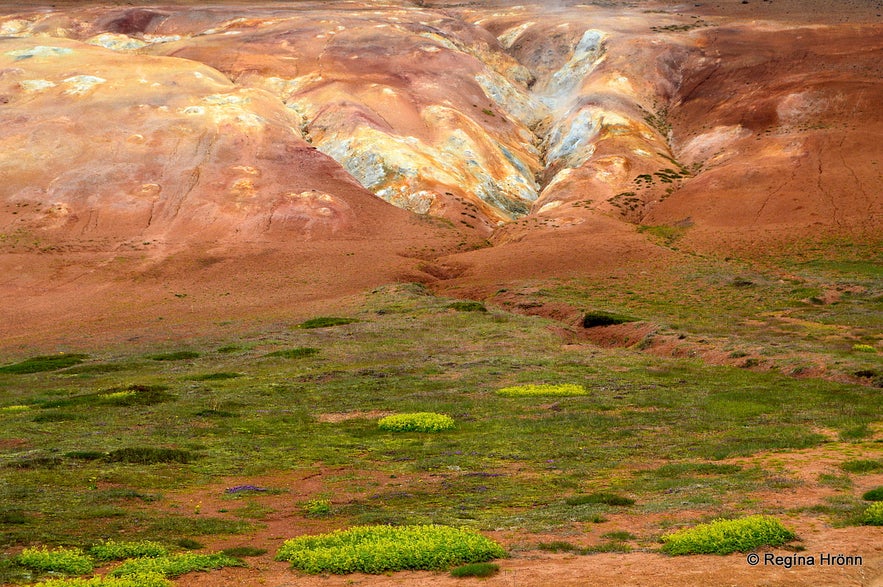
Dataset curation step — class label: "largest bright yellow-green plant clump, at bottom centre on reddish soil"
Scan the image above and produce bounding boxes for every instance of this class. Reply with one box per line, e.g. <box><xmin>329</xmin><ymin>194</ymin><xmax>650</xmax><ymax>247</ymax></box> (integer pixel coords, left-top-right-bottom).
<box><xmin>276</xmin><ymin>525</ymin><xmax>506</xmax><ymax>574</ymax></box>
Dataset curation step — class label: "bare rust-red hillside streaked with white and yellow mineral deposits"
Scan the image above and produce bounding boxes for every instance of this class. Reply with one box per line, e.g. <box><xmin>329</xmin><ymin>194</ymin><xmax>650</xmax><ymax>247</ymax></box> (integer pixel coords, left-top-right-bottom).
<box><xmin>0</xmin><ymin>0</ymin><xmax>883</xmax><ymax>338</ymax></box>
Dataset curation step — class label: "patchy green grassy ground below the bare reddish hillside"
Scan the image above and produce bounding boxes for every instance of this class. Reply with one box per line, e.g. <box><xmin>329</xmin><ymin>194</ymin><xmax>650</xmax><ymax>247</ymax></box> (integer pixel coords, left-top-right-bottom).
<box><xmin>0</xmin><ymin>258</ymin><xmax>883</xmax><ymax>581</ymax></box>
